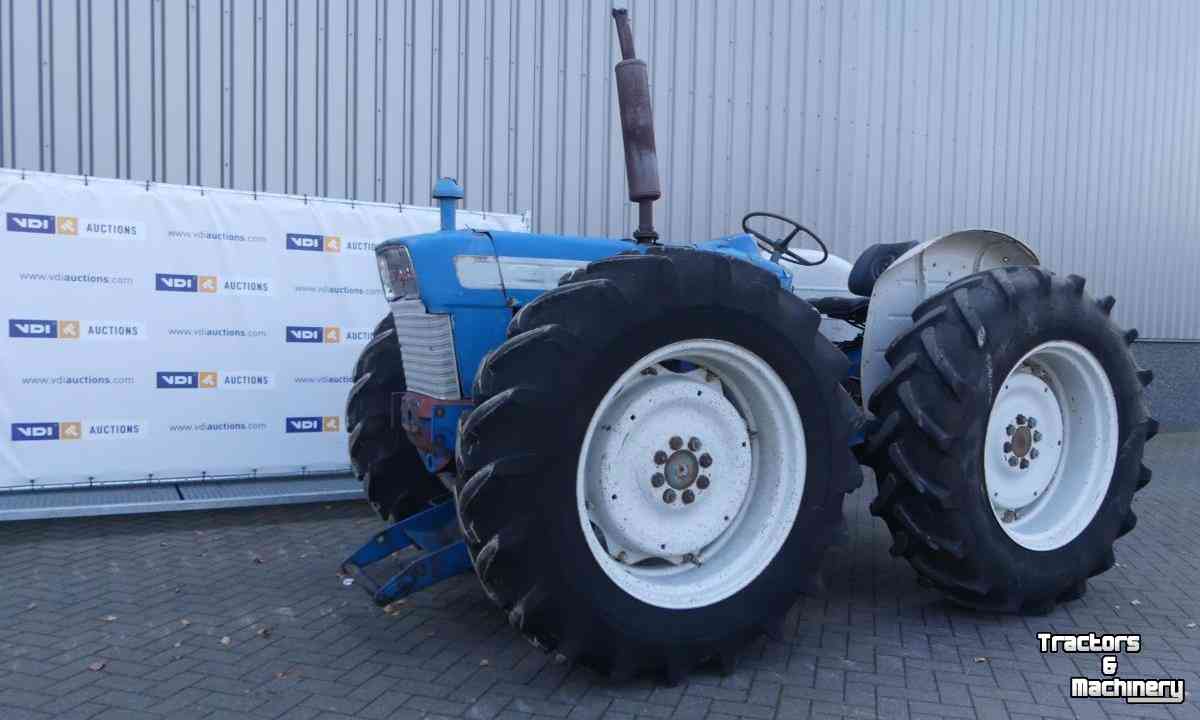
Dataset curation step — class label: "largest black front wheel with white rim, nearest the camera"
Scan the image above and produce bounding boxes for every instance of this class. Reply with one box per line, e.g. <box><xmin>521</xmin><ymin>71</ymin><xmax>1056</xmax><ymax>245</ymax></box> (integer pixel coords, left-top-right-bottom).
<box><xmin>457</xmin><ymin>248</ymin><xmax>862</xmax><ymax>682</ymax></box>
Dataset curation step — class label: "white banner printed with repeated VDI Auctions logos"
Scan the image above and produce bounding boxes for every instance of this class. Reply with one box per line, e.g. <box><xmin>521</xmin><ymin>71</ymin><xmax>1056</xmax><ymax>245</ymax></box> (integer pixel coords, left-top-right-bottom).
<box><xmin>0</xmin><ymin>170</ymin><xmax>528</xmax><ymax>488</ymax></box>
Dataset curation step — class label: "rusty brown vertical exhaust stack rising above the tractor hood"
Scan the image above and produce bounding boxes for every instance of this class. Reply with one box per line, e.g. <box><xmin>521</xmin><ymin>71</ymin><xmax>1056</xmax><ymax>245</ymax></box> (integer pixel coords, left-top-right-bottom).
<box><xmin>612</xmin><ymin>8</ymin><xmax>662</xmax><ymax>244</ymax></box>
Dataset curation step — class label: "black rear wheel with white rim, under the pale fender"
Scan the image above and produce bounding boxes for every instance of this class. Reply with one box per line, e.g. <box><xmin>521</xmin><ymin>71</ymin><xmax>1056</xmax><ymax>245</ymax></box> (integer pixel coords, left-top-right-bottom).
<box><xmin>866</xmin><ymin>268</ymin><xmax>1158</xmax><ymax>614</ymax></box>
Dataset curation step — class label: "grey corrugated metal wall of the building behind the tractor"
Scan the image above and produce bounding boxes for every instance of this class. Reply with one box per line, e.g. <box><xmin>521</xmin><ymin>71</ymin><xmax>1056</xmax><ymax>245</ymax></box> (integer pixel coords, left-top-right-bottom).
<box><xmin>0</xmin><ymin>0</ymin><xmax>1200</xmax><ymax>338</ymax></box>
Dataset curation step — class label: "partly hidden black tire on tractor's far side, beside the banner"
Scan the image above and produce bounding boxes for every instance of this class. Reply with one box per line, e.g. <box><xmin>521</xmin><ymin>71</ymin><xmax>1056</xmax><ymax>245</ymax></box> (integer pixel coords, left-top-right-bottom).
<box><xmin>346</xmin><ymin>313</ymin><xmax>446</xmax><ymax>522</ymax></box>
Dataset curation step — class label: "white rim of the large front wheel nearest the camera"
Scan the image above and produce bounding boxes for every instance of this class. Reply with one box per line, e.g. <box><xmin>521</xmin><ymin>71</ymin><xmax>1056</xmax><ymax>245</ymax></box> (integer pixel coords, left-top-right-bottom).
<box><xmin>576</xmin><ymin>340</ymin><xmax>808</xmax><ymax>610</ymax></box>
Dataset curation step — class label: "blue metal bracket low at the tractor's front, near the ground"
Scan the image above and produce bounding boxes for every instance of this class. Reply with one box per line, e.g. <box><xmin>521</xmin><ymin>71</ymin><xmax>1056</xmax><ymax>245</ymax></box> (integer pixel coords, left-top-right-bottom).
<box><xmin>341</xmin><ymin>500</ymin><xmax>472</xmax><ymax>606</ymax></box>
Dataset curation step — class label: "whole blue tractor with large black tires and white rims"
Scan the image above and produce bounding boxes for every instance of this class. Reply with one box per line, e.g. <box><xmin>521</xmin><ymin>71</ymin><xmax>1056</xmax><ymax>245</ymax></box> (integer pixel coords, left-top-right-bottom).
<box><xmin>344</xmin><ymin>10</ymin><xmax>1157</xmax><ymax>680</ymax></box>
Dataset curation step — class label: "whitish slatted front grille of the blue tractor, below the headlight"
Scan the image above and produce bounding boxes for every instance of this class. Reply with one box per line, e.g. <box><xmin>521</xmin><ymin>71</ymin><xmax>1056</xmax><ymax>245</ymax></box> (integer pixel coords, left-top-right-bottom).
<box><xmin>391</xmin><ymin>300</ymin><xmax>462</xmax><ymax>400</ymax></box>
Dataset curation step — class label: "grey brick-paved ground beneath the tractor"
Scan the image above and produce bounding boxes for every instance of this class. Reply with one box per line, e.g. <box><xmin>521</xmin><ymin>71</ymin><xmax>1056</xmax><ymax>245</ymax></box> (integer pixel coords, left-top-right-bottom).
<box><xmin>0</xmin><ymin>434</ymin><xmax>1200</xmax><ymax>720</ymax></box>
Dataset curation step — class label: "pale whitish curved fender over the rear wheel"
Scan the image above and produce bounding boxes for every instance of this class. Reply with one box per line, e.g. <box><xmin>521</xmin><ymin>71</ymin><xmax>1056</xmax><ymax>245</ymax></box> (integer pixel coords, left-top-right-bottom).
<box><xmin>862</xmin><ymin>229</ymin><xmax>1040</xmax><ymax>406</ymax></box>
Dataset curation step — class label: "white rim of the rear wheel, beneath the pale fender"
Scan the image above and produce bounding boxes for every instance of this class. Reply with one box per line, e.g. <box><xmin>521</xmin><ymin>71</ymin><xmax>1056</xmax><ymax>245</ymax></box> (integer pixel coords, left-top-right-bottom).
<box><xmin>984</xmin><ymin>341</ymin><xmax>1117</xmax><ymax>551</ymax></box>
